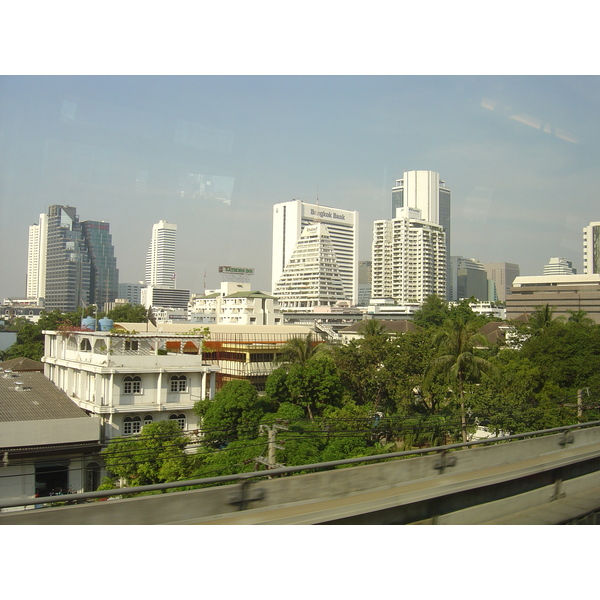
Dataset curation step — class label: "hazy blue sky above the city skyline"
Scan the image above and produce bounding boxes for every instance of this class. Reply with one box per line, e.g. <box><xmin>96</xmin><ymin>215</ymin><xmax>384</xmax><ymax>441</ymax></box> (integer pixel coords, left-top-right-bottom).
<box><xmin>0</xmin><ymin>75</ymin><xmax>600</xmax><ymax>298</ymax></box>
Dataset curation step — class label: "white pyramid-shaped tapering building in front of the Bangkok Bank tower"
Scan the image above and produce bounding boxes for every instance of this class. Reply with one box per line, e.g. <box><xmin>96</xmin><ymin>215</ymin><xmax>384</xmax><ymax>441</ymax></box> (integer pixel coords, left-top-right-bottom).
<box><xmin>273</xmin><ymin>223</ymin><xmax>346</xmax><ymax>310</ymax></box>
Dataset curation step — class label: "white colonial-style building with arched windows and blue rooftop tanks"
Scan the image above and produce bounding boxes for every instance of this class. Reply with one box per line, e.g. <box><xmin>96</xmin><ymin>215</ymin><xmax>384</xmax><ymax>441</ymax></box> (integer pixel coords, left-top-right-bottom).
<box><xmin>42</xmin><ymin>330</ymin><xmax>219</xmax><ymax>439</ymax></box>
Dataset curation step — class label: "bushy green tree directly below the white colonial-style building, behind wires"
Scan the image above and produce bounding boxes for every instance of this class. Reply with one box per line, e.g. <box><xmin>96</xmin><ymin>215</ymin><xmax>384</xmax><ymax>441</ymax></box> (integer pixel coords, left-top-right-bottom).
<box><xmin>102</xmin><ymin>421</ymin><xmax>191</xmax><ymax>486</ymax></box>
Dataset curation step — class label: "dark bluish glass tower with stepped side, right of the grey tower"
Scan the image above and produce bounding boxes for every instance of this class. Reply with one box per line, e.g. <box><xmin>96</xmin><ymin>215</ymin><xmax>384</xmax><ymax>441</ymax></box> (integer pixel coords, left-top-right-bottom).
<box><xmin>81</xmin><ymin>221</ymin><xmax>119</xmax><ymax>310</ymax></box>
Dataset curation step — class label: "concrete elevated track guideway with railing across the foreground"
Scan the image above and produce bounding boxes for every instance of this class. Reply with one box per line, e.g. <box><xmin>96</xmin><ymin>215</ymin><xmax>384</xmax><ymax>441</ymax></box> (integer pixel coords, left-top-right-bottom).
<box><xmin>0</xmin><ymin>421</ymin><xmax>600</xmax><ymax>525</ymax></box>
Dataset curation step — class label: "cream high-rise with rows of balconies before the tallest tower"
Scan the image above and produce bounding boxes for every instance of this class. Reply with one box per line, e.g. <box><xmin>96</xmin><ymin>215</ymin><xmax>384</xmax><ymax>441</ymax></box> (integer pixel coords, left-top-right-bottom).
<box><xmin>371</xmin><ymin>207</ymin><xmax>447</xmax><ymax>304</ymax></box>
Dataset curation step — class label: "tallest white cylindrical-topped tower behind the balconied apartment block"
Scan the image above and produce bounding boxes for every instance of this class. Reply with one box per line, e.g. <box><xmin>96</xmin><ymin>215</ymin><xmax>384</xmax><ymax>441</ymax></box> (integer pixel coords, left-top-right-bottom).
<box><xmin>392</xmin><ymin>171</ymin><xmax>451</xmax><ymax>293</ymax></box>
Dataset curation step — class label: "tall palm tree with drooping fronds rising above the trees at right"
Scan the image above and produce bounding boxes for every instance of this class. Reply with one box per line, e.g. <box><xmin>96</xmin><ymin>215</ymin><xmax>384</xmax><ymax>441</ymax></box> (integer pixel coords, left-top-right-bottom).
<box><xmin>423</xmin><ymin>318</ymin><xmax>496</xmax><ymax>442</ymax></box>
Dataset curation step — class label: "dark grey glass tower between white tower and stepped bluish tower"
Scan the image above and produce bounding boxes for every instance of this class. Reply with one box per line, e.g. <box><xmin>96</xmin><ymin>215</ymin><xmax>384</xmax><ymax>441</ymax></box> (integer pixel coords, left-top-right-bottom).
<box><xmin>45</xmin><ymin>204</ymin><xmax>91</xmax><ymax>312</ymax></box>
